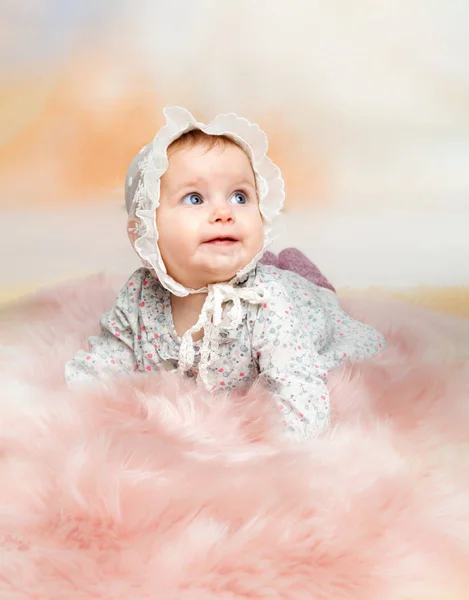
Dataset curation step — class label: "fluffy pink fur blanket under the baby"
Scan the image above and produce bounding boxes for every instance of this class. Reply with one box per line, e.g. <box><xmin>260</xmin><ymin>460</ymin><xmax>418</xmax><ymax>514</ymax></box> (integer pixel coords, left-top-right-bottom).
<box><xmin>0</xmin><ymin>277</ymin><xmax>469</xmax><ymax>600</ymax></box>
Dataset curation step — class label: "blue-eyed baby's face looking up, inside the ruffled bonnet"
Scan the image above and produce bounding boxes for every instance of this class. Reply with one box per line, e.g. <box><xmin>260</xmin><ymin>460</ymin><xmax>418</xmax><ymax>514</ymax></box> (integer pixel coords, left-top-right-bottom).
<box><xmin>156</xmin><ymin>144</ymin><xmax>264</xmax><ymax>289</ymax></box>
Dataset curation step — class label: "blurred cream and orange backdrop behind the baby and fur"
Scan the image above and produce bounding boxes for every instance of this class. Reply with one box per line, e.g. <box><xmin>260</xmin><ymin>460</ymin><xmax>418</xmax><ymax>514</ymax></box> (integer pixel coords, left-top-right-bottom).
<box><xmin>0</xmin><ymin>0</ymin><xmax>469</xmax><ymax>311</ymax></box>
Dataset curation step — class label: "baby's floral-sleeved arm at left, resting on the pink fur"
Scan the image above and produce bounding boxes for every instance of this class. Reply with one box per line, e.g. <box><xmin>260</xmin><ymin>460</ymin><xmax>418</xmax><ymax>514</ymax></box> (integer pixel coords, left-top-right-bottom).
<box><xmin>65</xmin><ymin>271</ymin><xmax>139</xmax><ymax>385</ymax></box>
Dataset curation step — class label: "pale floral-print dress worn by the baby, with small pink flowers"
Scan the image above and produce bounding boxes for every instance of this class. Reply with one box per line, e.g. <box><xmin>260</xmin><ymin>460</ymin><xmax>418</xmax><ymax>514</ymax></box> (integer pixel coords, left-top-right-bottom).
<box><xmin>65</xmin><ymin>264</ymin><xmax>385</xmax><ymax>438</ymax></box>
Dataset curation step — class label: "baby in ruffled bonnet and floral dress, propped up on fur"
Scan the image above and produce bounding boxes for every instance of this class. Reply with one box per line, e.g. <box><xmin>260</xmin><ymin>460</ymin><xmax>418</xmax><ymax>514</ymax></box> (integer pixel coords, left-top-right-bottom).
<box><xmin>66</xmin><ymin>107</ymin><xmax>385</xmax><ymax>438</ymax></box>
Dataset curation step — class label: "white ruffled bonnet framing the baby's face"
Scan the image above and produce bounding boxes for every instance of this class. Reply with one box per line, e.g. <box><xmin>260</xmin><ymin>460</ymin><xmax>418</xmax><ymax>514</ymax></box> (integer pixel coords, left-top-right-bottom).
<box><xmin>125</xmin><ymin>106</ymin><xmax>285</xmax><ymax>296</ymax></box>
